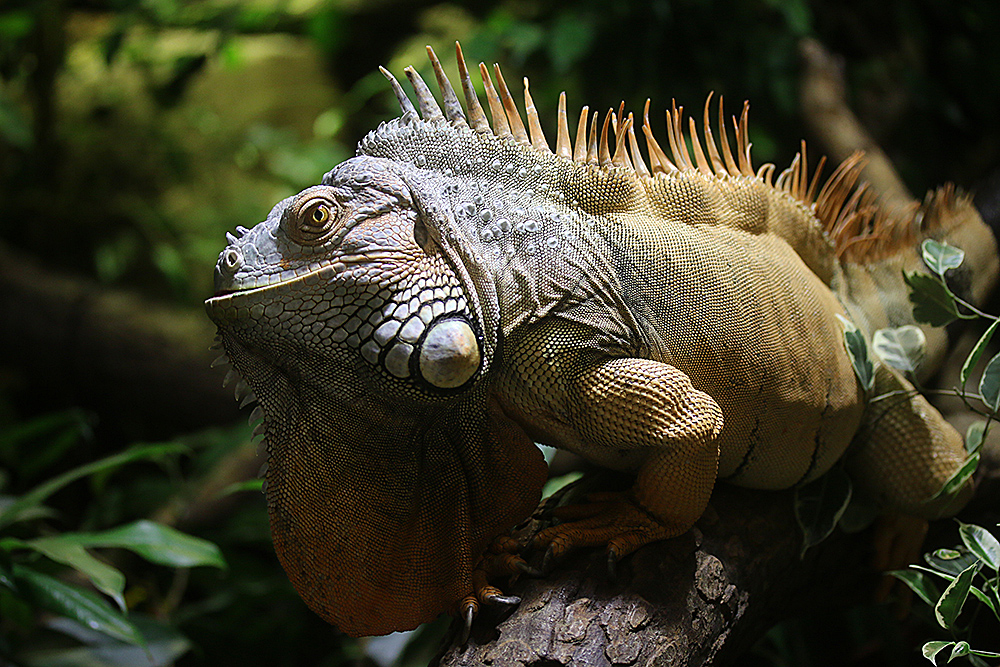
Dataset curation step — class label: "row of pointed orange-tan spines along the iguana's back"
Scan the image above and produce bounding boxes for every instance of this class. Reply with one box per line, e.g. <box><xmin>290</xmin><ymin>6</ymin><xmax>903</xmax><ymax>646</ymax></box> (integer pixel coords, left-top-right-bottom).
<box><xmin>379</xmin><ymin>42</ymin><xmax>956</xmax><ymax>263</ymax></box>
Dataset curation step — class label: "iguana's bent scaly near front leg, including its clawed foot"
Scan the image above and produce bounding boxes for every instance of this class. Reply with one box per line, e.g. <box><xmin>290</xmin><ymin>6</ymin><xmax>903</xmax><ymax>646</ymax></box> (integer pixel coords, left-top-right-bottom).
<box><xmin>534</xmin><ymin>358</ymin><xmax>722</xmax><ymax>561</ymax></box>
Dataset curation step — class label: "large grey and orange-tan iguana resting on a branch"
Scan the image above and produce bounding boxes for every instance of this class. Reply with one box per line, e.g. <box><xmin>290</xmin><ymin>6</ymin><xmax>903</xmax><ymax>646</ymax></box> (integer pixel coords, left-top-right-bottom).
<box><xmin>206</xmin><ymin>48</ymin><xmax>998</xmax><ymax>635</ymax></box>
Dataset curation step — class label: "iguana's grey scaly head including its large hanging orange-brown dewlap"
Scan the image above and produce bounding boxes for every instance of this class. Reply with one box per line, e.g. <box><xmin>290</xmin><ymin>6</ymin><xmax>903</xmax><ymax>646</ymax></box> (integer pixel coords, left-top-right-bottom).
<box><xmin>206</xmin><ymin>54</ymin><xmax>545</xmax><ymax>635</ymax></box>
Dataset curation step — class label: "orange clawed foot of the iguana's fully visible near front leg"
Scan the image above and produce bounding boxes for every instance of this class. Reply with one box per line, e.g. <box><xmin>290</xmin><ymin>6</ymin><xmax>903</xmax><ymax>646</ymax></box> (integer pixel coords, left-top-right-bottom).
<box><xmin>531</xmin><ymin>493</ymin><xmax>678</xmax><ymax>578</ymax></box>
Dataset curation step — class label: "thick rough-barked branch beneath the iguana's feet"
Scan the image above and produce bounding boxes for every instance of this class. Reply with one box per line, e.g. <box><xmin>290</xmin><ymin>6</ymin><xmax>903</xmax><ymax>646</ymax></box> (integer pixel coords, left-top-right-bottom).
<box><xmin>436</xmin><ymin>468</ymin><xmax>1000</xmax><ymax>667</ymax></box>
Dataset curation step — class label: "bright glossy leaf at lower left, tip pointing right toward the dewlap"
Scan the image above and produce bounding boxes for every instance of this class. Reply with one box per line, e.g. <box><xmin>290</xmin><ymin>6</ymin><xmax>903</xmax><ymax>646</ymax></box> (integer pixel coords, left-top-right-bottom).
<box><xmin>65</xmin><ymin>521</ymin><xmax>226</xmax><ymax>568</ymax></box>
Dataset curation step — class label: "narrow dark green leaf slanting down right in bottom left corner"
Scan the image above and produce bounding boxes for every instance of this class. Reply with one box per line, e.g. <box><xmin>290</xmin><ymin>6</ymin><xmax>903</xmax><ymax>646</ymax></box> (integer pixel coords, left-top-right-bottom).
<box><xmin>13</xmin><ymin>565</ymin><xmax>143</xmax><ymax>644</ymax></box>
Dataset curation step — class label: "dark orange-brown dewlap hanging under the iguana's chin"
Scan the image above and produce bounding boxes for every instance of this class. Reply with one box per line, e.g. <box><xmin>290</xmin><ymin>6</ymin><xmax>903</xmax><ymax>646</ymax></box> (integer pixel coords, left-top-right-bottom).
<box><xmin>267</xmin><ymin>394</ymin><xmax>546</xmax><ymax>636</ymax></box>
